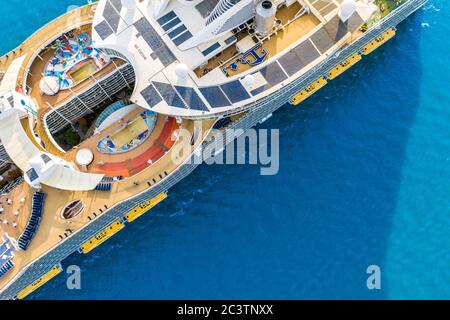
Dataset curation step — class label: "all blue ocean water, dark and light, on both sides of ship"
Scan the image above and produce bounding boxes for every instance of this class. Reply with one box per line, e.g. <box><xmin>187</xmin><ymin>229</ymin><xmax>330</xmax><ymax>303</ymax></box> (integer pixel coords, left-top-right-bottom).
<box><xmin>0</xmin><ymin>0</ymin><xmax>450</xmax><ymax>299</ymax></box>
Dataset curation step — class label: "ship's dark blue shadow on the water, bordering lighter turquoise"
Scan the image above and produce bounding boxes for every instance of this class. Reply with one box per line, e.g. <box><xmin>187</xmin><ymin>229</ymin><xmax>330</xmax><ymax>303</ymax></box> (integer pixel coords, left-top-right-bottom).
<box><xmin>33</xmin><ymin>12</ymin><xmax>422</xmax><ymax>299</ymax></box>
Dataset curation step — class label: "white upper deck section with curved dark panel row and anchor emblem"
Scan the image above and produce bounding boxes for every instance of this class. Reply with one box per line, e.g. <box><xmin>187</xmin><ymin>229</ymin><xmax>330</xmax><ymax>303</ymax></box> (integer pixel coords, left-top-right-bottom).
<box><xmin>93</xmin><ymin>0</ymin><xmax>377</xmax><ymax>117</ymax></box>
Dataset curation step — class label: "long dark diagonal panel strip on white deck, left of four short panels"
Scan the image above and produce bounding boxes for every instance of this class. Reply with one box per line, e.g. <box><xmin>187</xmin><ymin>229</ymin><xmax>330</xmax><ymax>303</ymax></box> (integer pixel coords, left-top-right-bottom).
<box><xmin>134</xmin><ymin>17</ymin><xmax>176</xmax><ymax>67</ymax></box>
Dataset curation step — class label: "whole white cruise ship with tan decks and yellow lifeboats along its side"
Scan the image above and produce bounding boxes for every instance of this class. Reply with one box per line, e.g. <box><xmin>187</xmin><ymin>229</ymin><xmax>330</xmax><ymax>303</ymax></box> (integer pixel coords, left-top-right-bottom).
<box><xmin>0</xmin><ymin>0</ymin><xmax>427</xmax><ymax>300</ymax></box>
